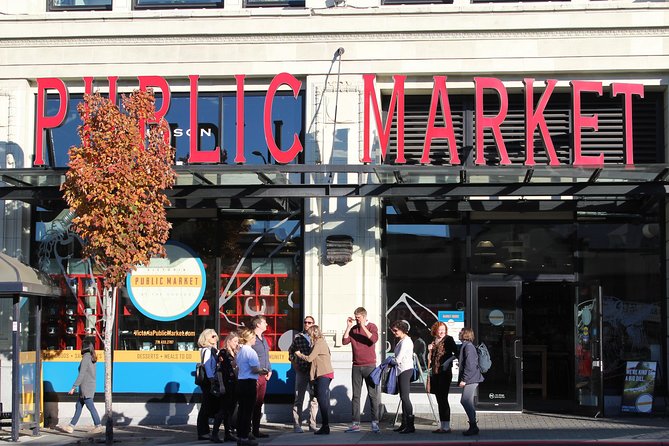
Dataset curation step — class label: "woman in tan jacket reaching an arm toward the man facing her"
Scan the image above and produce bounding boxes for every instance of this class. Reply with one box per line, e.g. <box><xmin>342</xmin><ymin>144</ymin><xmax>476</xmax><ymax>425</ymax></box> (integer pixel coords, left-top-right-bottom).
<box><xmin>295</xmin><ymin>325</ymin><xmax>334</xmax><ymax>435</ymax></box>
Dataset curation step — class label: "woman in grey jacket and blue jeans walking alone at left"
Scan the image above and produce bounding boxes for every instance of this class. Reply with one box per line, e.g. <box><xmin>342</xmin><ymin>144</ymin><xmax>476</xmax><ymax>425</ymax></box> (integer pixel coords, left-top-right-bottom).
<box><xmin>62</xmin><ymin>341</ymin><xmax>104</xmax><ymax>433</ymax></box>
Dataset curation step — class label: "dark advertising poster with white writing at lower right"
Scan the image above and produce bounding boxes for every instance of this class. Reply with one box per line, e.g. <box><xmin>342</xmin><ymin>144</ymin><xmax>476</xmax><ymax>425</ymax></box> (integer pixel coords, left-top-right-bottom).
<box><xmin>621</xmin><ymin>361</ymin><xmax>657</xmax><ymax>413</ymax></box>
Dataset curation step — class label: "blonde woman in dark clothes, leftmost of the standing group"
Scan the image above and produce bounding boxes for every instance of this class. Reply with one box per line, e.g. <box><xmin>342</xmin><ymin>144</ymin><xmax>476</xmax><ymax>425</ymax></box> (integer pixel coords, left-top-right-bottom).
<box><xmin>197</xmin><ymin>328</ymin><xmax>218</xmax><ymax>440</ymax></box>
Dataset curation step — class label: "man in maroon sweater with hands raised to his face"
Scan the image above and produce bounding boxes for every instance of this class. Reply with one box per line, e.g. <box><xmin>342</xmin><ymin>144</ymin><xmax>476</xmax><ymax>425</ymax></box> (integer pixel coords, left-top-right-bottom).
<box><xmin>342</xmin><ymin>307</ymin><xmax>381</xmax><ymax>434</ymax></box>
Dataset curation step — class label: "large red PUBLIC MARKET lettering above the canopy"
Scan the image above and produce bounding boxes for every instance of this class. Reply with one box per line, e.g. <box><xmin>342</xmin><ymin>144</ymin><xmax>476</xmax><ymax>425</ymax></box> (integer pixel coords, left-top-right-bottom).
<box><xmin>34</xmin><ymin>73</ymin><xmax>644</xmax><ymax>166</ymax></box>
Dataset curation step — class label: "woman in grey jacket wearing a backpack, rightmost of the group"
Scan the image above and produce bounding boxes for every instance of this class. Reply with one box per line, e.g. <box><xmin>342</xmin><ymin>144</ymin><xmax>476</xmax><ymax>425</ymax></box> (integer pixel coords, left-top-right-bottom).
<box><xmin>458</xmin><ymin>327</ymin><xmax>484</xmax><ymax>436</ymax></box>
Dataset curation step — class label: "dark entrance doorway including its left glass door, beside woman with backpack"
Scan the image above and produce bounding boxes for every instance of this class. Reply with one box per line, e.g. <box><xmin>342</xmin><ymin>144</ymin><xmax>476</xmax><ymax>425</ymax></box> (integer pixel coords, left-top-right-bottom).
<box><xmin>469</xmin><ymin>276</ymin><xmax>577</xmax><ymax>413</ymax></box>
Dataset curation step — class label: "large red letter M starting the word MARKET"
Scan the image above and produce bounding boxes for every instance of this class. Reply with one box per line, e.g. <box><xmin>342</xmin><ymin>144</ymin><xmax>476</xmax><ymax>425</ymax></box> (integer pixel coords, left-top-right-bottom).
<box><xmin>361</xmin><ymin>74</ymin><xmax>406</xmax><ymax>164</ymax></box>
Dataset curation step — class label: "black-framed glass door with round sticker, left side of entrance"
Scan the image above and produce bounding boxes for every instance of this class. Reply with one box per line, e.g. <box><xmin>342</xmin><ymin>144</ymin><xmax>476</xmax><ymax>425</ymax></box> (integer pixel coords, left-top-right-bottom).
<box><xmin>470</xmin><ymin>278</ymin><xmax>523</xmax><ymax>410</ymax></box>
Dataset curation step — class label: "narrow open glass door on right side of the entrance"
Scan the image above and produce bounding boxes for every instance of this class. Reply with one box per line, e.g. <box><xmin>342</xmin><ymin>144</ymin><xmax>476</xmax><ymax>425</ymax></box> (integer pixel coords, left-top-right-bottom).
<box><xmin>574</xmin><ymin>283</ymin><xmax>604</xmax><ymax>417</ymax></box>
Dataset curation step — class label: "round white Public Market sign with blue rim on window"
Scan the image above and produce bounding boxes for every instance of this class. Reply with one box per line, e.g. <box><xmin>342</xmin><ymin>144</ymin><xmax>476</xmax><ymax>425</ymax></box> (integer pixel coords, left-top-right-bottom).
<box><xmin>126</xmin><ymin>242</ymin><xmax>207</xmax><ymax>321</ymax></box>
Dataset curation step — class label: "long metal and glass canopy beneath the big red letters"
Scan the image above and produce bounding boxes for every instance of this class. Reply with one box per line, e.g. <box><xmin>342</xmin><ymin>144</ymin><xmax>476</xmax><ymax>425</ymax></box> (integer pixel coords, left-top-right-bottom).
<box><xmin>0</xmin><ymin>164</ymin><xmax>669</xmax><ymax>208</ymax></box>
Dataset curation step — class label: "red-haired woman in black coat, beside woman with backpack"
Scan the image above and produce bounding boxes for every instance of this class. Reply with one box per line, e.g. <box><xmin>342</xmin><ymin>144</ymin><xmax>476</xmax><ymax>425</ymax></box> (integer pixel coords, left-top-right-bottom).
<box><xmin>428</xmin><ymin>322</ymin><xmax>458</xmax><ymax>434</ymax></box>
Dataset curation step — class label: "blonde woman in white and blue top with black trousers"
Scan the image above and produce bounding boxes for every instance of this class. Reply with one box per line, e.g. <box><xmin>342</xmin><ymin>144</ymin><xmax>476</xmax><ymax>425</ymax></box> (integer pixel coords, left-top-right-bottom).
<box><xmin>236</xmin><ymin>328</ymin><xmax>269</xmax><ymax>446</ymax></box>
